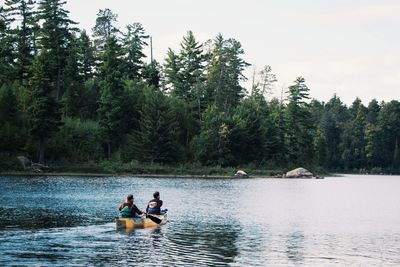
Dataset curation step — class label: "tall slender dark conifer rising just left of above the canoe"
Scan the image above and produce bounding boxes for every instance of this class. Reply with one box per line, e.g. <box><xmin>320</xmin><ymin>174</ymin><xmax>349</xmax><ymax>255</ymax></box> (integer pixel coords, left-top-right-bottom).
<box><xmin>98</xmin><ymin>37</ymin><xmax>124</xmax><ymax>157</ymax></box>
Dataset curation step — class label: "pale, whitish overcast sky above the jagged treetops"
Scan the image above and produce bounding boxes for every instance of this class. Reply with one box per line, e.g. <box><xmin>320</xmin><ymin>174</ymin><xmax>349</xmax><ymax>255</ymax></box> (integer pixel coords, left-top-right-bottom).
<box><xmin>0</xmin><ymin>0</ymin><xmax>400</xmax><ymax>105</ymax></box>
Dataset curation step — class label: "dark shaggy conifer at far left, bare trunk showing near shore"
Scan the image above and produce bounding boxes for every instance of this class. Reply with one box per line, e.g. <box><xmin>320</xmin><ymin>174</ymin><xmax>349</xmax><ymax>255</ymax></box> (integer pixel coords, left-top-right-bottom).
<box><xmin>28</xmin><ymin>51</ymin><xmax>62</xmax><ymax>164</ymax></box>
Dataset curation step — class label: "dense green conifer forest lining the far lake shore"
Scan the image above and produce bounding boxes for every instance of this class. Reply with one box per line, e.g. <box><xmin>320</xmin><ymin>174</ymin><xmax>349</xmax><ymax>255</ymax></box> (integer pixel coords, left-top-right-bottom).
<box><xmin>0</xmin><ymin>0</ymin><xmax>400</xmax><ymax>172</ymax></box>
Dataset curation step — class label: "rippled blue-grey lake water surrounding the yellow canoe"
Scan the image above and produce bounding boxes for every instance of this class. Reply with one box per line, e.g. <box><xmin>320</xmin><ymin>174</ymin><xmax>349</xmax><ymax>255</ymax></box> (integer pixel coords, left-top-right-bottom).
<box><xmin>0</xmin><ymin>175</ymin><xmax>400</xmax><ymax>266</ymax></box>
